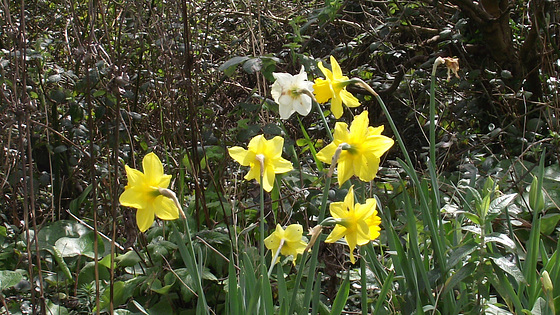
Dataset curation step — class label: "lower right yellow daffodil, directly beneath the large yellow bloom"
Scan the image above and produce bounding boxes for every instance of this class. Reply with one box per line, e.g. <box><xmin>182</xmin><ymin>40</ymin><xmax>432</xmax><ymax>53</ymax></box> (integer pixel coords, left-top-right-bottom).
<box><xmin>325</xmin><ymin>186</ymin><xmax>381</xmax><ymax>263</ymax></box>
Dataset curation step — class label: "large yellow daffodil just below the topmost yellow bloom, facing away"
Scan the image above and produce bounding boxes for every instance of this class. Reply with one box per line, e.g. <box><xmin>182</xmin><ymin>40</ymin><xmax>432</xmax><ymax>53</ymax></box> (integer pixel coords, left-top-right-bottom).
<box><xmin>317</xmin><ymin>111</ymin><xmax>394</xmax><ymax>186</ymax></box>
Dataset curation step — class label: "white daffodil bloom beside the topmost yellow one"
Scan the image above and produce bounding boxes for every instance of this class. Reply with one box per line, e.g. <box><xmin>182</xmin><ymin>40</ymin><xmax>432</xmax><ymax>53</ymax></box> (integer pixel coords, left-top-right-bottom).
<box><xmin>270</xmin><ymin>66</ymin><xmax>313</xmax><ymax>119</ymax></box>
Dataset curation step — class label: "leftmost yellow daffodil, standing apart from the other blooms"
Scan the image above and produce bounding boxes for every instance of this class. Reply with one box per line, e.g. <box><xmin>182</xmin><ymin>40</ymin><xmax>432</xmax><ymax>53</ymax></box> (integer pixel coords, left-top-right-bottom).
<box><xmin>119</xmin><ymin>153</ymin><xmax>179</xmax><ymax>232</ymax></box>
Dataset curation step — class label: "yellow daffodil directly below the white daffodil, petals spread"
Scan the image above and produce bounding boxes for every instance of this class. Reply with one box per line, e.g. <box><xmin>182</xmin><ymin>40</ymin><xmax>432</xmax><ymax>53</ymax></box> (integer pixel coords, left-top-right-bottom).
<box><xmin>228</xmin><ymin>135</ymin><xmax>293</xmax><ymax>192</ymax></box>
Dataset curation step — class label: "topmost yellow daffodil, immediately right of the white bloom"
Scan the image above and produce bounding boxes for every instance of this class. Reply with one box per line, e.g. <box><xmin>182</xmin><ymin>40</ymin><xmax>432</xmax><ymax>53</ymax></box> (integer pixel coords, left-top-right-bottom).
<box><xmin>313</xmin><ymin>56</ymin><xmax>360</xmax><ymax>119</ymax></box>
